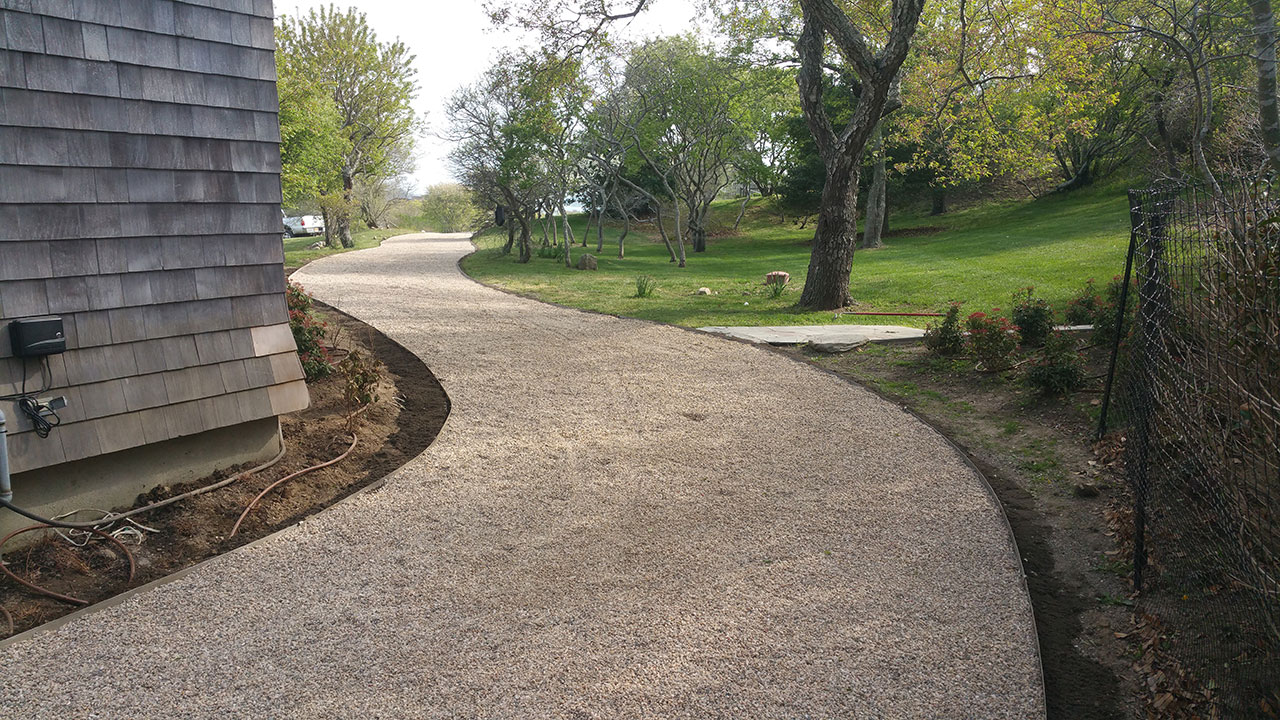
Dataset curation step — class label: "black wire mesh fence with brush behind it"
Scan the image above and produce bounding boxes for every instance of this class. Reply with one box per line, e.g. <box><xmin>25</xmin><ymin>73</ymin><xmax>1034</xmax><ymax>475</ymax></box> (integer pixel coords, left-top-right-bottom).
<box><xmin>1101</xmin><ymin>181</ymin><xmax>1280</xmax><ymax>717</ymax></box>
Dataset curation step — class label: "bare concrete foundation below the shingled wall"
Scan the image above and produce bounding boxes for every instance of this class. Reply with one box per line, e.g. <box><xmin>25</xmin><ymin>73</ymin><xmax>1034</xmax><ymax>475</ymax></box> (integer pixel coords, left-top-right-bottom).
<box><xmin>0</xmin><ymin>418</ymin><xmax>280</xmax><ymax>542</ymax></box>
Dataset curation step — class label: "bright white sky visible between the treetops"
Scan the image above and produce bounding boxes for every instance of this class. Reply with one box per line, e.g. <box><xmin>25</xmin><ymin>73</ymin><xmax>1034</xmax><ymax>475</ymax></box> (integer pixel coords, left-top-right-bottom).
<box><xmin>275</xmin><ymin>0</ymin><xmax>698</xmax><ymax>192</ymax></box>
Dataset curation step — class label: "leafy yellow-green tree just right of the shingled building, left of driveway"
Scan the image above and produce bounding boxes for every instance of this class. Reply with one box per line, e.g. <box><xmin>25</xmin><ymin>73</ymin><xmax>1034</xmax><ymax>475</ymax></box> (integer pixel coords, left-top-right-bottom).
<box><xmin>276</xmin><ymin>5</ymin><xmax>417</xmax><ymax>247</ymax></box>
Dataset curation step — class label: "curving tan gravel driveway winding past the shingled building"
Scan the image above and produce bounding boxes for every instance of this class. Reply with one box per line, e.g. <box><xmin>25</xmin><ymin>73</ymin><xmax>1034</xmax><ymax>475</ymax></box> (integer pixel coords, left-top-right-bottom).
<box><xmin>0</xmin><ymin>236</ymin><xmax>1043</xmax><ymax>720</ymax></box>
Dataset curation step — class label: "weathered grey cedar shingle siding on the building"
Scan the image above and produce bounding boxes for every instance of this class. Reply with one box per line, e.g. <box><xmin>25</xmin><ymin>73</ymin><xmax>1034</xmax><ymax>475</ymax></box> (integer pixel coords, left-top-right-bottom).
<box><xmin>0</xmin><ymin>0</ymin><xmax>307</xmax><ymax>471</ymax></box>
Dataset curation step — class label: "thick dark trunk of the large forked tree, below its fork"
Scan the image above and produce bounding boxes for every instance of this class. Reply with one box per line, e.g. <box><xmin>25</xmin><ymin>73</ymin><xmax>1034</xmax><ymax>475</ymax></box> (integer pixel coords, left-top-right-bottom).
<box><xmin>800</xmin><ymin>155</ymin><xmax>860</xmax><ymax>310</ymax></box>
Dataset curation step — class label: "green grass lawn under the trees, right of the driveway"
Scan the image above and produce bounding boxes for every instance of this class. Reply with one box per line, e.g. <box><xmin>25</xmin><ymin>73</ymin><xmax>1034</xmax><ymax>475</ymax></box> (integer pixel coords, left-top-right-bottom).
<box><xmin>462</xmin><ymin>179</ymin><xmax>1129</xmax><ymax>327</ymax></box>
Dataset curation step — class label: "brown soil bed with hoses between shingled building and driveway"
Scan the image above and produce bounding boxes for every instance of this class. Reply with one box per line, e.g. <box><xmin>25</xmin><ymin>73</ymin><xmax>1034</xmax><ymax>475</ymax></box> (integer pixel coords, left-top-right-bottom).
<box><xmin>0</xmin><ymin>302</ymin><xmax>449</xmax><ymax>638</ymax></box>
